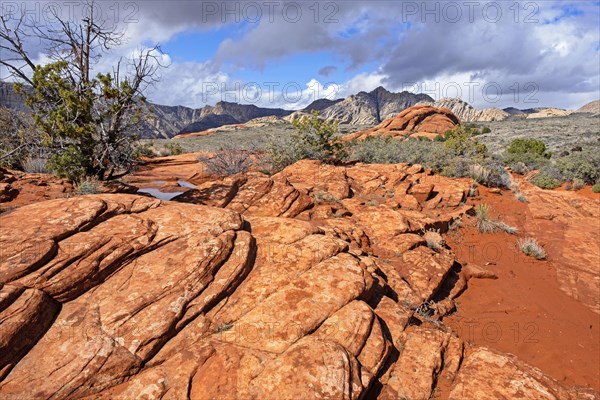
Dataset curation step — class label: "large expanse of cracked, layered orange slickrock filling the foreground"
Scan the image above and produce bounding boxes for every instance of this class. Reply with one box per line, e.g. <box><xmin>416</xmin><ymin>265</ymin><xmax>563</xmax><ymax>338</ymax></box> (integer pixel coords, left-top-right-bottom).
<box><xmin>0</xmin><ymin>161</ymin><xmax>598</xmax><ymax>399</ymax></box>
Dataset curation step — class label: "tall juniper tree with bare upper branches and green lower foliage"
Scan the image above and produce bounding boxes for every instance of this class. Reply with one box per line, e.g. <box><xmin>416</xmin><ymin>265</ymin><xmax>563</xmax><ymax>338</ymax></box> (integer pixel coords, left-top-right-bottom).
<box><xmin>0</xmin><ymin>2</ymin><xmax>163</xmax><ymax>179</ymax></box>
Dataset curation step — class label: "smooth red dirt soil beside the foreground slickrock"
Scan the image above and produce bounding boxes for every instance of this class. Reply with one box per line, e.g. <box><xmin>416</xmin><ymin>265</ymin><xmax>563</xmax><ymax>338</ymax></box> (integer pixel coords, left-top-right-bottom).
<box><xmin>444</xmin><ymin>187</ymin><xmax>600</xmax><ymax>390</ymax></box>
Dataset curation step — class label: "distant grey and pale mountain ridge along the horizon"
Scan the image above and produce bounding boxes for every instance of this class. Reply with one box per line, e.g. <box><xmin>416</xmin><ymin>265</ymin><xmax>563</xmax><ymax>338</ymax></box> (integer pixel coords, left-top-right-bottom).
<box><xmin>0</xmin><ymin>81</ymin><xmax>598</xmax><ymax>139</ymax></box>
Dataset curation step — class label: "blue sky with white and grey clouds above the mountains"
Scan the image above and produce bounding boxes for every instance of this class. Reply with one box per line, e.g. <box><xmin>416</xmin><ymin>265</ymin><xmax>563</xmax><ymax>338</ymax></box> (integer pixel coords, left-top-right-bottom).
<box><xmin>0</xmin><ymin>0</ymin><xmax>600</xmax><ymax>109</ymax></box>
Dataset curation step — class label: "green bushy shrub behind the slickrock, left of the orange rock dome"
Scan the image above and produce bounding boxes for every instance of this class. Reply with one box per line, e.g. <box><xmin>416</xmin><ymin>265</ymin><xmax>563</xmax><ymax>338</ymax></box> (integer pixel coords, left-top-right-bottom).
<box><xmin>263</xmin><ymin>110</ymin><xmax>347</xmax><ymax>171</ymax></box>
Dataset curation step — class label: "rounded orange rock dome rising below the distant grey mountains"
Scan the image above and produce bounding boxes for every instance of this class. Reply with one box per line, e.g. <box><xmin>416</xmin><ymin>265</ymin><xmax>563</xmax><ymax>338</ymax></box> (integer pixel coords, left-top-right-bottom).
<box><xmin>344</xmin><ymin>105</ymin><xmax>460</xmax><ymax>140</ymax></box>
